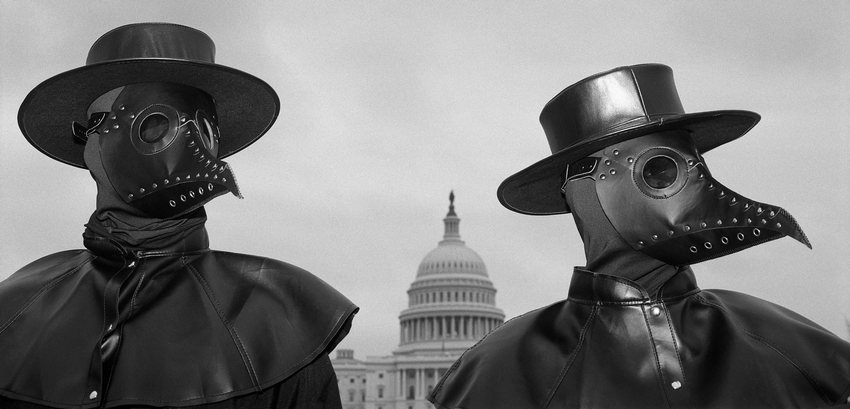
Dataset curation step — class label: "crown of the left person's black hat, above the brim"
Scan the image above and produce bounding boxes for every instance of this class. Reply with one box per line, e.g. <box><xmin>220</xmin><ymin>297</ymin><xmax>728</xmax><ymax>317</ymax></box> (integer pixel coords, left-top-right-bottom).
<box><xmin>86</xmin><ymin>23</ymin><xmax>215</xmax><ymax>65</ymax></box>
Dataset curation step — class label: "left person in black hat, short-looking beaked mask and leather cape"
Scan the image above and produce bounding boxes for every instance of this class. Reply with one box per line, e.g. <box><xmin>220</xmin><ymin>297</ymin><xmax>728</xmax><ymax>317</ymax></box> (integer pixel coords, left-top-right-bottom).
<box><xmin>0</xmin><ymin>23</ymin><xmax>357</xmax><ymax>408</ymax></box>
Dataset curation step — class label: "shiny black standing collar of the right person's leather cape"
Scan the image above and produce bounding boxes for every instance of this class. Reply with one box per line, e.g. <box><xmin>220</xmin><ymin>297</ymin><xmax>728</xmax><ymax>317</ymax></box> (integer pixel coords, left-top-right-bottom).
<box><xmin>568</xmin><ymin>266</ymin><xmax>699</xmax><ymax>304</ymax></box>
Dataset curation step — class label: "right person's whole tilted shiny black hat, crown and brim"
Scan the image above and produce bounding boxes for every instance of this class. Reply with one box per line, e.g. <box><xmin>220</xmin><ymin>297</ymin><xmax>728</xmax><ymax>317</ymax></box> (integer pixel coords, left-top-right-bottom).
<box><xmin>496</xmin><ymin>64</ymin><xmax>761</xmax><ymax>215</ymax></box>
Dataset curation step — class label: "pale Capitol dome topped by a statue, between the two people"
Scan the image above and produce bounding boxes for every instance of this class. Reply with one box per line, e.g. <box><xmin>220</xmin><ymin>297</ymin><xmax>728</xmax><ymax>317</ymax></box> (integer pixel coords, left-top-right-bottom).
<box><xmin>395</xmin><ymin>192</ymin><xmax>505</xmax><ymax>354</ymax></box>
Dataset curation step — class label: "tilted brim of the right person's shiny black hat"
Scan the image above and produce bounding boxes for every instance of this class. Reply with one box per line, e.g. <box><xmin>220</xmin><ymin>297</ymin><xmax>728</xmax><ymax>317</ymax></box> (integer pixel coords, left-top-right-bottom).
<box><xmin>496</xmin><ymin>110</ymin><xmax>761</xmax><ymax>215</ymax></box>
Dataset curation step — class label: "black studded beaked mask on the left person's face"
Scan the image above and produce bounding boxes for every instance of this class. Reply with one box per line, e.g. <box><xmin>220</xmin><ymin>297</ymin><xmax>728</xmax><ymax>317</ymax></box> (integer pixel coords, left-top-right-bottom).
<box><xmin>79</xmin><ymin>83</ymin><xmax>241</xmax><ymax>218</ymax></box>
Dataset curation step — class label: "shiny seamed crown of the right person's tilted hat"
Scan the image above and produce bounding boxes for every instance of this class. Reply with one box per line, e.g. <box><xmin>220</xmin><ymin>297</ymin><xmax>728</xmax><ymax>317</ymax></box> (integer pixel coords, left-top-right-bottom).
<box><xmin>540</xmin><ymin>64</ymin><xmax>684</xmax><ymax>153</ymax></box>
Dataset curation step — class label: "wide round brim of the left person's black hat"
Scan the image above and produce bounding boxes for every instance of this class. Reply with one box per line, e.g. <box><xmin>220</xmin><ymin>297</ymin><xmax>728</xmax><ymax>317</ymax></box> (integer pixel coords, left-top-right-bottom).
<box><xmin>18</xmin><ymin>58</ymin><xmax>280</xmax><ymax>168</ymax></box>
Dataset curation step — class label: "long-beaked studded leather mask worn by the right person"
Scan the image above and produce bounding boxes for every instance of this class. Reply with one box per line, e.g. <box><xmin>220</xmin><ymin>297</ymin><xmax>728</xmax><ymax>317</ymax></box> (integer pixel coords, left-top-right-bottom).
<box><xmin>584</xmin><ymin>131</ymin><xmax>811</xmax><ymax>266</ymax></box>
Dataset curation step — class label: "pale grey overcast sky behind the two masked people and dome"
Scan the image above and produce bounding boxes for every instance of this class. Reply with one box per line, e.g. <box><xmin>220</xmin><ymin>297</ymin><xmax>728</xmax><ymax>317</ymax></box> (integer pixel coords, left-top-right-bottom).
<box><xmin>0</xmin><ymin>0</ymin><xmax>850</xmax><ymax>358</ymax></box>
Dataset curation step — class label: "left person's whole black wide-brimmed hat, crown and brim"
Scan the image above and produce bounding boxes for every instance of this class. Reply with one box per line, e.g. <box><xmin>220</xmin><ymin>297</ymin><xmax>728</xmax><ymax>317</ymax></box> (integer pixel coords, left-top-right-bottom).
<box><xmin>18</xmin><ymin>23</ymin><xmax>280</xmax><ymax>168</ymax></box>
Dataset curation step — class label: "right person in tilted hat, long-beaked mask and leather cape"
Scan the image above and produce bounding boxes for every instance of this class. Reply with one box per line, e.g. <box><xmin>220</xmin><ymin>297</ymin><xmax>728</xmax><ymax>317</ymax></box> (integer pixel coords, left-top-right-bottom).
<box><xmin>430</xmin><ymin>64</ymin><xmax>850</xmax><ymax>408</ymax></box>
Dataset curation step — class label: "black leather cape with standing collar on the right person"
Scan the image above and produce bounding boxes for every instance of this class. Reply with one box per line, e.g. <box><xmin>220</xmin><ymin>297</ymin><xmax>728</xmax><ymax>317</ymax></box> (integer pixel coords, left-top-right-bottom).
<box><xmin>429</xmin><ymin>268</ymin><xmax>850</xmax><ymax>408</ymax></box>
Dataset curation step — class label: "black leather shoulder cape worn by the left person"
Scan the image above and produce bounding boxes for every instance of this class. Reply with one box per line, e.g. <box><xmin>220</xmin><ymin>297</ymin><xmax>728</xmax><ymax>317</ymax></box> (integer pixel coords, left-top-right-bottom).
<box><xmin>0</xmin><ymin>228</ymin><xmax>357</xmax><ymax>408</ymax></box>
